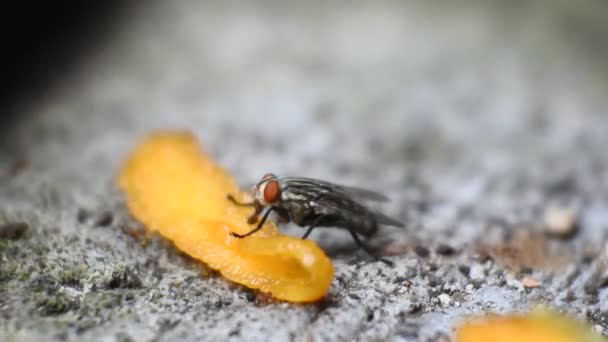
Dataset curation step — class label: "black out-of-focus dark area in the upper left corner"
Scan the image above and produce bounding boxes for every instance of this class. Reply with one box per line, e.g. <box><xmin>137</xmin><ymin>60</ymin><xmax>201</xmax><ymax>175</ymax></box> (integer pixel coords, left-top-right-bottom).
<box><xmin>0</xmin><ymin>1</ymin><xmax>129</xmax><ymax>115</ymax></box>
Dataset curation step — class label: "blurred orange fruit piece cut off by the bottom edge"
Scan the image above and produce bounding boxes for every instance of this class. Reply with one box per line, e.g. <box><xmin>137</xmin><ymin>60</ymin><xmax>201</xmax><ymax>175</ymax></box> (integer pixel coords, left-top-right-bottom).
<box><xmin>455</xmin><ymin>308</ymin><xmax>605</xmax><ymax>342</ymax></box>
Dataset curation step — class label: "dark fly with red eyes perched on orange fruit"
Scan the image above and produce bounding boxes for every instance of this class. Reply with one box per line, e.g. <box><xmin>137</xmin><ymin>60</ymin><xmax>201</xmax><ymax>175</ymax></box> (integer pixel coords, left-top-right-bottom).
<box><xmin>228</xmin><ymin>173</ymin><xmax>404</xmax><ymax>264</ymax></box>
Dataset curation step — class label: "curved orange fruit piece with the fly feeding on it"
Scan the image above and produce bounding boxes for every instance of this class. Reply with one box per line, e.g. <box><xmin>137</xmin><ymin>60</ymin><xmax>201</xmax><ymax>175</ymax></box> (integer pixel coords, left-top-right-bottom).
<box><xmin>119</xmin><ymin>132</ymin><xmax>334</xmax><ymax>302</ymax></box>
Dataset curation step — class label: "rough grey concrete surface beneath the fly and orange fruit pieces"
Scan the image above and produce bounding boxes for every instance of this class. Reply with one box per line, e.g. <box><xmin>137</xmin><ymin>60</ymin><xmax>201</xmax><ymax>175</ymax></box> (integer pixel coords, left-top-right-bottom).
<box><xmin>0</xmin><ymin>1</ymin><xmax>608</xmax><ymax>341</ymax></box>
